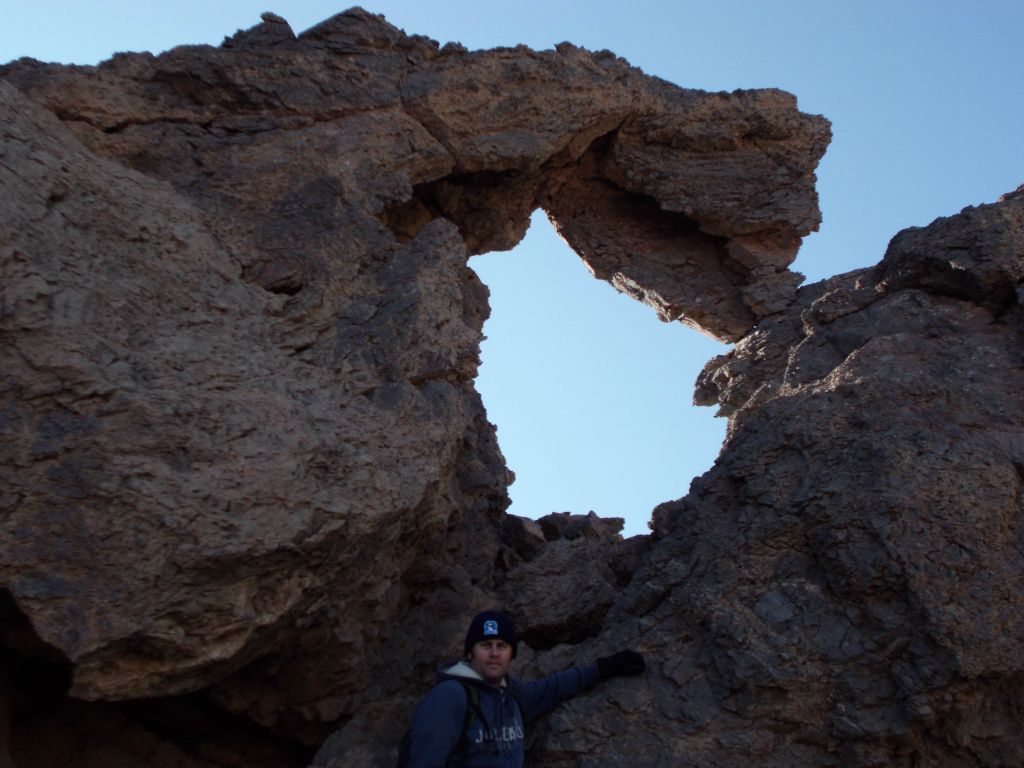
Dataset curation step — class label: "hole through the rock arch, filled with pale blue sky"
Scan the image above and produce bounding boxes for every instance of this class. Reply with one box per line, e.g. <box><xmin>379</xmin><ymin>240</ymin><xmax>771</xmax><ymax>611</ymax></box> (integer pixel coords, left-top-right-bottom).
<box><xmin>470</xmin><ymin>210</ymin><xmax>725</xmax><ymax>536</ymax></box>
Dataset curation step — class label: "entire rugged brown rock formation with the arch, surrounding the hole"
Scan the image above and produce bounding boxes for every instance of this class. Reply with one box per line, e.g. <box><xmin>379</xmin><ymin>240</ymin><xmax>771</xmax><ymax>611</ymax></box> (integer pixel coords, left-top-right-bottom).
<box><xmin>0</xmin><ymin>9</ymin><xmax>1024</xmax><ymax>768</ymax></box>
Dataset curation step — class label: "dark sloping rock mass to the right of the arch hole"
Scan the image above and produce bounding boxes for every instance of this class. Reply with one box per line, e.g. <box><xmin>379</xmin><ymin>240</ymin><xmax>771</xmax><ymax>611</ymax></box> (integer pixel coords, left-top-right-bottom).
<box><xmin>667</xmin><ymin>189</ymin><xmax>1024</xmax><ymax>765</ymax></box>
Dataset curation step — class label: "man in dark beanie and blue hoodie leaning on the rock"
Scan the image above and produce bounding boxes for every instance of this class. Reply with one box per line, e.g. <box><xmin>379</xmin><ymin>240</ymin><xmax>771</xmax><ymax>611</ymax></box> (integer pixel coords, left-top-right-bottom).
<box><xmin>398</xmin><ymin>610</ymin><xmax>645</xmax><ymax>768</ymax></box>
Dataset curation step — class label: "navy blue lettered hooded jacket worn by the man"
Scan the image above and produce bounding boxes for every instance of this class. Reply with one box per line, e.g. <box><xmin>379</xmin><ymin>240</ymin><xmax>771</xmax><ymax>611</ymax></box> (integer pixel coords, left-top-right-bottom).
<box><xmin>409</xmin><ymin>662</ymin><xmax>597</xmax><ymax>768</ymax></box>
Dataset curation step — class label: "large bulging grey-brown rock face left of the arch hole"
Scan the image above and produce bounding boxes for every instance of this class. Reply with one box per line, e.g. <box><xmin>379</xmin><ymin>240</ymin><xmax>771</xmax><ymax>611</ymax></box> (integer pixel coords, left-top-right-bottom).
<box><xmin>2</xmin><ymin>70</ymin><xmax>491</xmax><ymax>698</ymax></box>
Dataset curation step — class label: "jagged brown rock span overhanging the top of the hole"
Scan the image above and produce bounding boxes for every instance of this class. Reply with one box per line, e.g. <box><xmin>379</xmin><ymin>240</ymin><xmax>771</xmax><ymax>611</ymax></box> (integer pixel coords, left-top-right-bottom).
<box><xmin>5</xmin><ymin>10</ymin><xmax>829</xmax><ymax>339</ymax></box>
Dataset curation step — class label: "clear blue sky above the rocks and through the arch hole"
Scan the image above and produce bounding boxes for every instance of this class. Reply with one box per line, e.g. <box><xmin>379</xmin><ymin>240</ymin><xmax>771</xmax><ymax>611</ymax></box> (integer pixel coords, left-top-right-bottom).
<box><xmin>0</xmin><ymin>0</ymin><xmax>1024</xmax><ymax>535</ymax></box>
